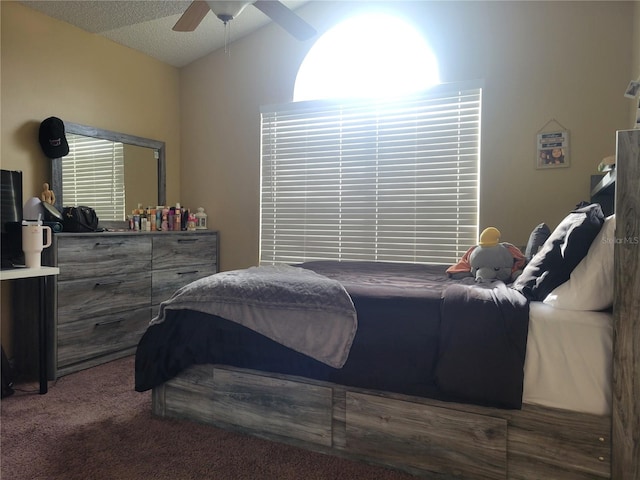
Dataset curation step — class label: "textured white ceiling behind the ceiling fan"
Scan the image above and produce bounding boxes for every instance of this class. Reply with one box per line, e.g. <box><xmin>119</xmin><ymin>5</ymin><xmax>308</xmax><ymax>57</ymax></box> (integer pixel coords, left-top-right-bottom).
<box><xmin>20</xmin><ymin>0</ymin><xmax>305</xmax><ymax>67</ymax></box>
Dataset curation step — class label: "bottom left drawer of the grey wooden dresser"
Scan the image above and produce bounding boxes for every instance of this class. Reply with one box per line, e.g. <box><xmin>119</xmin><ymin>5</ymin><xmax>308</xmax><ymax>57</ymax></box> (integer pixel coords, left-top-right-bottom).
<box><xmin>57</xmin><ymin>306</ymin><xmax>151</xmax><ymax>369</ymax></box>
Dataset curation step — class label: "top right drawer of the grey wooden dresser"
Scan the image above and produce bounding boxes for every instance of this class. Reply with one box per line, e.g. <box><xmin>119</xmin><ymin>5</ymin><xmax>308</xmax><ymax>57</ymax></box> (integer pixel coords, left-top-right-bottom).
<box><xmin>153</xmin><ymin>233</ymin><xmax>218</xmax><ymax>270</ymax></box>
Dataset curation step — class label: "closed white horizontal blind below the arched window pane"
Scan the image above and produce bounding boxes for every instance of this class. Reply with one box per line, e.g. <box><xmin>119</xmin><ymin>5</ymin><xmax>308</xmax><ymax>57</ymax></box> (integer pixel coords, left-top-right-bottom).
<box><xmin>260</xmin><ymin>86</ymin><xmax>481</xmax><ymax>264</ymax></box>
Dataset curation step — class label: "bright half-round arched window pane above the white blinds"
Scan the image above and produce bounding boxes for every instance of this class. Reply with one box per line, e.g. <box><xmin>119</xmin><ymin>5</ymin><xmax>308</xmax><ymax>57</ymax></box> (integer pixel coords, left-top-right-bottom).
<box><xmin>293</xmin><ymin>14</ymin><xmax>440</xmax><ymax>101</ymax></box>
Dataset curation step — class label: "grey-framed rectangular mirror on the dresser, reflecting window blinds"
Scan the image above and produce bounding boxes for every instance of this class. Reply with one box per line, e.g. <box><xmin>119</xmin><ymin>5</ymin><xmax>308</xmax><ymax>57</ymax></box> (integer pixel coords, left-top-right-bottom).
<box><xmin>51</xmin><ymin>122</ymin><xmax>166</xmax><ymax>226</ymax></box>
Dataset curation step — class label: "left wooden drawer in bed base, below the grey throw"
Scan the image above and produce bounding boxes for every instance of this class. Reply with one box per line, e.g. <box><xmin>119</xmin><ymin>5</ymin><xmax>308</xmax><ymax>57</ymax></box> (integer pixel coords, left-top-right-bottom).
<box><xmin>154</xmin><ymin>365</ymin><xmax>333</xmax><ymax>447</ymax></box>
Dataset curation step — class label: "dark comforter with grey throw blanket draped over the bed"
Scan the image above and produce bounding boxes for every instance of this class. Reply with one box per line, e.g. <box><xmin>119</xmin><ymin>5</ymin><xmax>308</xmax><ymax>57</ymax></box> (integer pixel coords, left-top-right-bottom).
<box><xmin>136</xmin><ymin>261</ymin><xmax>528</xmax><ymax>408</ymax></box>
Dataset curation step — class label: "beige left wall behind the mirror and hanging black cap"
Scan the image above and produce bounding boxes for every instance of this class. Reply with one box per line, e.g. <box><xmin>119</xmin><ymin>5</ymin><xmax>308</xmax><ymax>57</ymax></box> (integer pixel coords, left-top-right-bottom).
<box><xmin>0</xmin><ymin>1</ymin><xmax>180</xmax><ymax>356</ymax></box>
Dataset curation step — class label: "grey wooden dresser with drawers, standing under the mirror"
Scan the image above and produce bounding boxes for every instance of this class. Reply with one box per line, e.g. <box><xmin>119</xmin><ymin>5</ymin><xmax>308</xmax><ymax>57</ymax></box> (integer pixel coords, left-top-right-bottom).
<box><xmin>15</xmin><ymin>230</ymin><xmax>218</xmax><ymax>379</ymax></box>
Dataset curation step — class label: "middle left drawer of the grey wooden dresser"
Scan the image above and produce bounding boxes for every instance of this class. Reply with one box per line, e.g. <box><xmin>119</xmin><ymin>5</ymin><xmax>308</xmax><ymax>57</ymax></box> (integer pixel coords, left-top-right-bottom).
<box><xmin>58</xmin><ymin>271</ymin><xmax>151</xmax><ymax>324</ymax></box>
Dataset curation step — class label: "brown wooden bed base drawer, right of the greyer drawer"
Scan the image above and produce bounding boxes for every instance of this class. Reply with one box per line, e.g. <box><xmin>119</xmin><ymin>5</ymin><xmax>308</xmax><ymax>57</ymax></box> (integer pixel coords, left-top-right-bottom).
<box><xmin>346</xmin><ymin>392</ymin><xmax>507</xmax><ymax>480</ymax></box>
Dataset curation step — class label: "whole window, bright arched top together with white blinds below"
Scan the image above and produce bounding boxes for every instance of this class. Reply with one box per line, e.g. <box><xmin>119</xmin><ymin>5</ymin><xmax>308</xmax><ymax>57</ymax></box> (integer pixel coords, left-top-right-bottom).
<box><xmin>260</xmin><ymin>15</ymin><xmax>481</xmax><ymax>265</ymax></box>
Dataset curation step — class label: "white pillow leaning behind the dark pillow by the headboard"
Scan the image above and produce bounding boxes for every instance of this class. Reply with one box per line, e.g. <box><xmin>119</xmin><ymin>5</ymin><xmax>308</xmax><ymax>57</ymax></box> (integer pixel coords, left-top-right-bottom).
<box><xmin>544</xmin><ymin>215</ymin><xmax>616</xmax><ymax>310</ymax></box>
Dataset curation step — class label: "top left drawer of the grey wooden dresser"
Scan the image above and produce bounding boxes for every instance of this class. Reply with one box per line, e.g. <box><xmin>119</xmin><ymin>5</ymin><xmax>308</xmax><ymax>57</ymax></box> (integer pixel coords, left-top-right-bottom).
<box><xmin>57</xmin><ymin>234</ymin><xmax>151</xmax><ymax>282</ymax></box>
